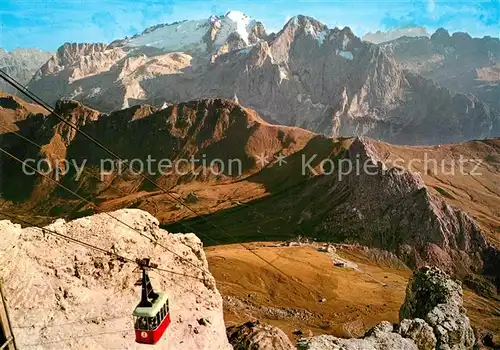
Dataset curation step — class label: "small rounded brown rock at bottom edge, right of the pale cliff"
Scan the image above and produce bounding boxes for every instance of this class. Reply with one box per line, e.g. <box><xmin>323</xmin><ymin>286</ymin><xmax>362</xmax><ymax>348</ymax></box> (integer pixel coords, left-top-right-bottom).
<box><xmin>227</xmin><ymin>321</ymin><xmax>295</xmax><ymax>350</ymax></box>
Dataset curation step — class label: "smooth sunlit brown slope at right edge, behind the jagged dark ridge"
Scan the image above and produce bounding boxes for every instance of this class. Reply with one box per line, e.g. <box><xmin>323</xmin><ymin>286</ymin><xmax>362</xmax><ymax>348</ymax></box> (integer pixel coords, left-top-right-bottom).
<box><xmin>374</xmin><ymin>138</ymin><xmax>500</xmax><ymax>246</ymax></box>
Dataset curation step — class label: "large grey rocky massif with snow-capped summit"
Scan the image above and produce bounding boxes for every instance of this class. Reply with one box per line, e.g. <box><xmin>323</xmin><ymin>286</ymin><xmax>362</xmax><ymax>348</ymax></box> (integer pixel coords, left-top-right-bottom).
<box><xmin>26</xmin><ymin>15</ymin><xmax>500</xmax><ymax>144</ymax></box>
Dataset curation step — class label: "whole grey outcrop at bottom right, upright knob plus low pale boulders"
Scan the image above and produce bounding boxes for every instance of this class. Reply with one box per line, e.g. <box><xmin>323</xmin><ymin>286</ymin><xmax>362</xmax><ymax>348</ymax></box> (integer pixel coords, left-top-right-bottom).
<box><xmin>298</xmin><ymin>267</ymin><xmax>475</xmax><ymax>350</ymax></box>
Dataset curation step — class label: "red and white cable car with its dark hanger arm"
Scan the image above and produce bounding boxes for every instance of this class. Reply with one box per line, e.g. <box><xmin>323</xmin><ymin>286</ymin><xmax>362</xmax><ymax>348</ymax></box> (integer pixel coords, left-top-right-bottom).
<box><xmin>133</xmin><ymin>259</ymin><xmax>170</xmax><ymax>344</ymax></box>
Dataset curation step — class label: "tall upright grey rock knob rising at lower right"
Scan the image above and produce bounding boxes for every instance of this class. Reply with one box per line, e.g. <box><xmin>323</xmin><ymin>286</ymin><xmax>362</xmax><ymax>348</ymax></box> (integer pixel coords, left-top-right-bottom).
<box><xmin>399</xmin><ymin>267</ymin><xmax>475</xmax><ymax>350</ymax></box>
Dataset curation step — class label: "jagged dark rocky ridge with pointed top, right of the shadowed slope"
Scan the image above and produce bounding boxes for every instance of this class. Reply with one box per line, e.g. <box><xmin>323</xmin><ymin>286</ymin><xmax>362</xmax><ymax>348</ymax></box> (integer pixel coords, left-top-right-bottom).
<box><xmin>317</xmin><ymin>138</ymin><xmax>489</xmax><ymax>272</ymax></box>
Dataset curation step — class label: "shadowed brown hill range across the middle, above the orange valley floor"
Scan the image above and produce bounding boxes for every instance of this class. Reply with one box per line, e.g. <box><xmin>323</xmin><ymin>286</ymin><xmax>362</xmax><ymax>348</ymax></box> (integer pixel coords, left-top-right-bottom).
<box><xmin>2</xmin><ymin>93</ymin><xmax>500</xmax><ymax>295</ymax></box>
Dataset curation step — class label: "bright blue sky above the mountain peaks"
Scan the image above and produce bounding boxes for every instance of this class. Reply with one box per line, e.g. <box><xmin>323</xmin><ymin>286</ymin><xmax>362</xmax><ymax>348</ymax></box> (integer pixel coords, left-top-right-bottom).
<box><xmin>0</xmin><ymin>0</ymin><xmax>500</xmax><ymax>51</ymax></box>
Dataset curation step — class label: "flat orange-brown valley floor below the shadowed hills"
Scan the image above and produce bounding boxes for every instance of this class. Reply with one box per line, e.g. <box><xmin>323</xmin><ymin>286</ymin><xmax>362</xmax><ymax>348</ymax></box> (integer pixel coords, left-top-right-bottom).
<box><xmin>205</xmin><ymin>242</ymin><xmax>500</xmax><ymax>339</ymax></box>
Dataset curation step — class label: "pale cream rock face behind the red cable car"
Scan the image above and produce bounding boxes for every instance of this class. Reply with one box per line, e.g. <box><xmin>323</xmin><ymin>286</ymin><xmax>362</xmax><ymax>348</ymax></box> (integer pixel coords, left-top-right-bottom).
<box><xmin>0</xmin><ymin>209</ymin><xmax>231</xmax><ymax>350</ymax></box>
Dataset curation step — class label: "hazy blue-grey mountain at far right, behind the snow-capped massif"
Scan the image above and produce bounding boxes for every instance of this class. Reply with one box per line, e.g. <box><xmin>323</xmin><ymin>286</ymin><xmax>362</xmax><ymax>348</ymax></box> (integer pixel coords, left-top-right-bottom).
<box><xmin>382</xmin><ymin>29</ymin><xmax>500</xmax><ymax>110</ymax></box>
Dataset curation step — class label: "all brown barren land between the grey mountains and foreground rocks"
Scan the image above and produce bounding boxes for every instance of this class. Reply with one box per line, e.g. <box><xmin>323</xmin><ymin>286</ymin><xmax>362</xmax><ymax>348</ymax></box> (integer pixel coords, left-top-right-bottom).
<box><xmin>0</xmin><ymin>92</ymin><xmax>500</xmax><ymax>342</ymax></box>
